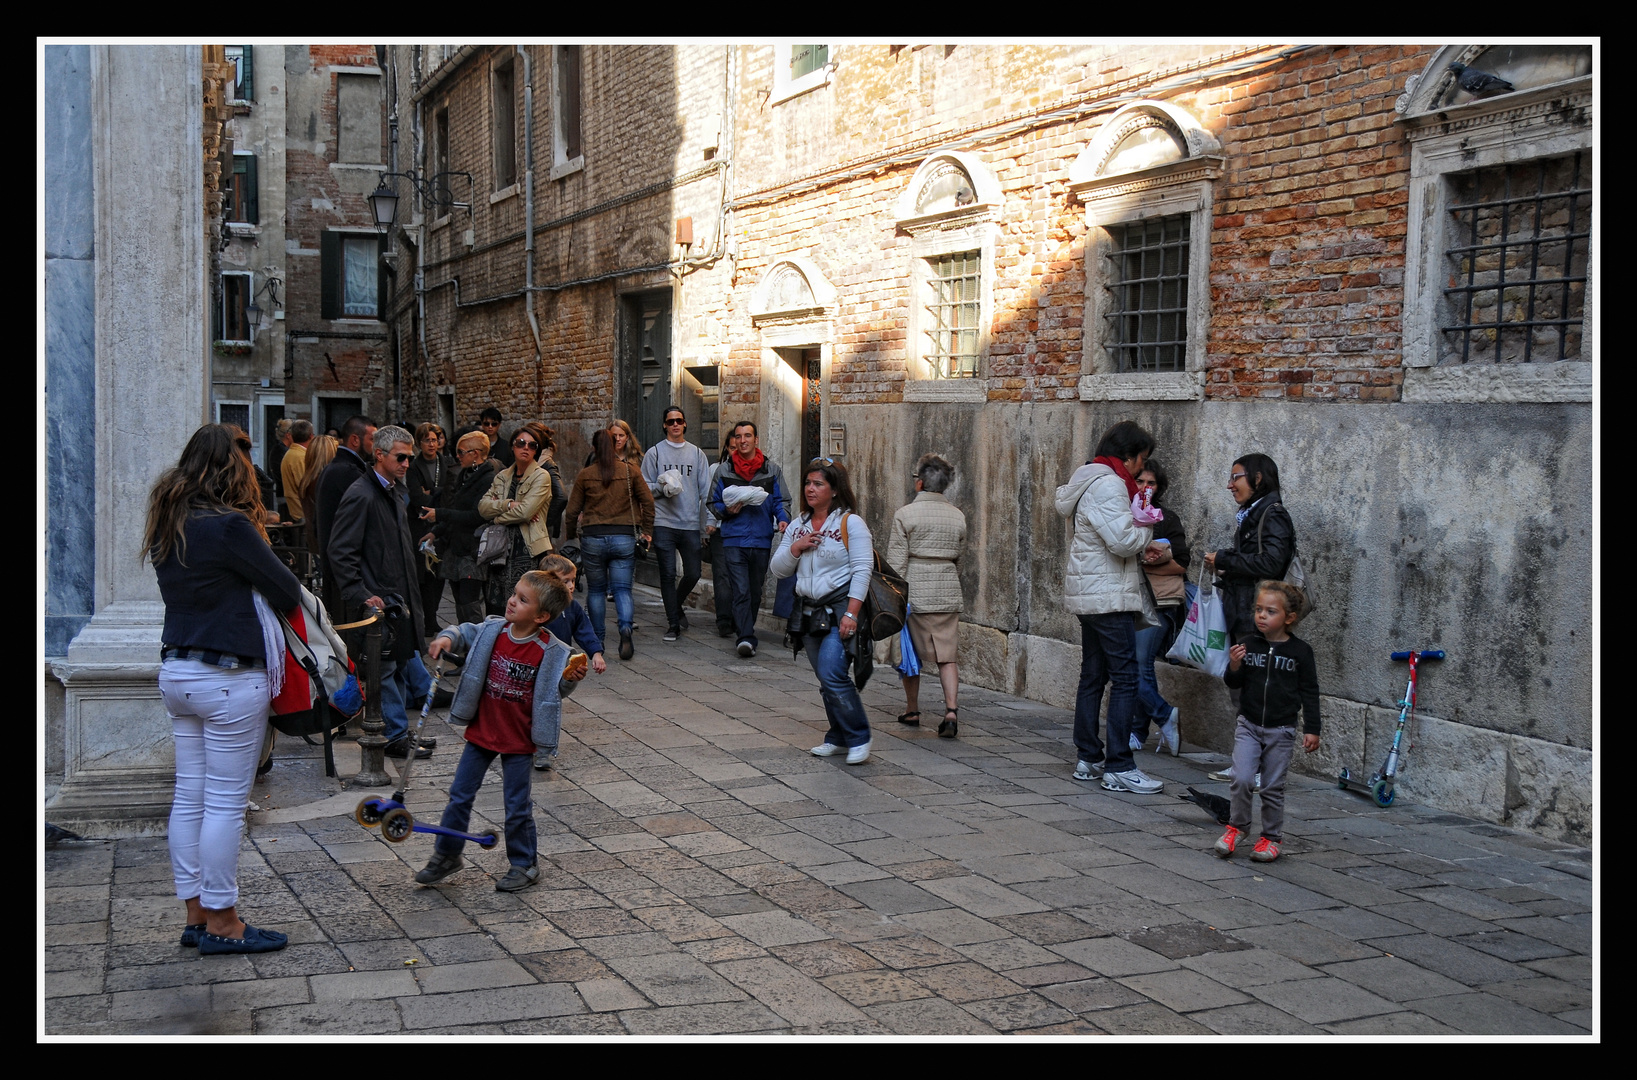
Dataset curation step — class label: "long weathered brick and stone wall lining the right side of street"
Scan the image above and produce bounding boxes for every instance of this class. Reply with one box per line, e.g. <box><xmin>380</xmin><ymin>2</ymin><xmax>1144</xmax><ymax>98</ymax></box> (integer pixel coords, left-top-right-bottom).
<box><xmin>379</xmin><ymin>41</ymin><xmax>1591</xmax><ymax>835</ymax></box>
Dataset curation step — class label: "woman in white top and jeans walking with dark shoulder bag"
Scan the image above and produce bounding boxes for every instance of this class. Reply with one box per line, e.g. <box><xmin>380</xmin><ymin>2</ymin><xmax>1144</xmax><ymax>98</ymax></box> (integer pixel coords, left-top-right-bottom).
<box><xmin>768</xmin><ymin>458</ymin><xmax>876</xmax><ymax>764</ymax></box>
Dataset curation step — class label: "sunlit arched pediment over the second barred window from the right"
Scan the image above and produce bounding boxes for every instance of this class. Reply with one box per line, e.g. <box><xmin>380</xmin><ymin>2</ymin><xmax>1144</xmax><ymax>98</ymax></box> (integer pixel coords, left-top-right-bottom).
<box><xmin>1069</xmin><ymin>101</ymin><xmax>1221</xmax><ymax>196</ymax></box>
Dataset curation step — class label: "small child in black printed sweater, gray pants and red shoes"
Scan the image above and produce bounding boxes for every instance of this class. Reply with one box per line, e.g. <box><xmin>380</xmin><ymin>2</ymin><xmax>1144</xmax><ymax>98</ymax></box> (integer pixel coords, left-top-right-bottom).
<box><xmin>1216</xmin><ymin>581</ymin><xmax>1319</xmax><ymax>862</ymax></box>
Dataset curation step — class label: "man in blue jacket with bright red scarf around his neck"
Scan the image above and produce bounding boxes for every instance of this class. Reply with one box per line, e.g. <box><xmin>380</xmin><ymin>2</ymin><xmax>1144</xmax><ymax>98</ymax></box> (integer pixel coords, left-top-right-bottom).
<box><xmin>710</xmin><ymin>421</ymin><xmax>791</xmax><ymax>659</ymax></box>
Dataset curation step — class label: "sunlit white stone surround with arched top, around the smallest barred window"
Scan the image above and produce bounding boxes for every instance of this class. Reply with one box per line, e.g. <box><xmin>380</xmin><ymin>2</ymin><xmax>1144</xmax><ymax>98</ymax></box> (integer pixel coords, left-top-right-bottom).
<box><xmin>894</xmin><ymin>151</ymin><xmax>1005</xmax><ymax>401</ymax></box>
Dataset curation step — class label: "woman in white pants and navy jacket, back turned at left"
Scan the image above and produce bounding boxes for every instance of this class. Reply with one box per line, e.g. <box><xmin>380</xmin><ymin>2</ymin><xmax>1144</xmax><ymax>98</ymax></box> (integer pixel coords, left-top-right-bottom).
<box><xmin>144</xmin><ymin>424</ymin><xmax>301</xmax><ymax>952</ymax></box>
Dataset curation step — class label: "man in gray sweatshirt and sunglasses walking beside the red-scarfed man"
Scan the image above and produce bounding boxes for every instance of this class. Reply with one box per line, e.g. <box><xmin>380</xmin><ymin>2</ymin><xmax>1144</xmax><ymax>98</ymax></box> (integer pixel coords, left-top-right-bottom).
<box><xmin>642</xmin><ymin>406</ymin><xmax>710</xmax><ymax>641</ymax></box>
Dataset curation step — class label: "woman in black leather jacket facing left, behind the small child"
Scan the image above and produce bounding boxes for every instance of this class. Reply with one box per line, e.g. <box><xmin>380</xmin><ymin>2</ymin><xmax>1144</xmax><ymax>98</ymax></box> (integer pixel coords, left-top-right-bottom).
<box><xmin>1205</xmin><ymin>453</ymin><xmax>1297</xmax><ymax>641</ymax></box>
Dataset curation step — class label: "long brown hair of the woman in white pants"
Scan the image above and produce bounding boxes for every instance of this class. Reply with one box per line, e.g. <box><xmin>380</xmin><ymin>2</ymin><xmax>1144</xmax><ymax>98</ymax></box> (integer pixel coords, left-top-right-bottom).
<box><xmin>142</xmin><ymin>424</ymin><xmax>267</xmax><ymax>566</ymax></box>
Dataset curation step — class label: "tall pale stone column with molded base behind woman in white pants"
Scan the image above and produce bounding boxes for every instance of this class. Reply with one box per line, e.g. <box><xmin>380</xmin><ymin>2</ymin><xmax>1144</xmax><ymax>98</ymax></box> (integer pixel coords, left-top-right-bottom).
<box><xmin>47</xmin><ymin>44</ymin><xmax>210</xmax><ymax>836</ymax></box>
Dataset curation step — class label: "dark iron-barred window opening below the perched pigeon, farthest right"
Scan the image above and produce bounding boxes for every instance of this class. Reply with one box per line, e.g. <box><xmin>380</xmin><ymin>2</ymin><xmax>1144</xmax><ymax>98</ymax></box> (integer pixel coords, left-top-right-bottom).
<box><xmin>1439</xmin><ymin>154</ymin><xmax>1591</xmax><ymax>363</ymax></box>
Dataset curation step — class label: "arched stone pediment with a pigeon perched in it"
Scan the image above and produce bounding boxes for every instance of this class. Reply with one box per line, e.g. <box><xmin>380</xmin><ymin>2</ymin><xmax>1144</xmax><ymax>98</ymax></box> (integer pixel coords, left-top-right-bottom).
<box><xmin>1395</xmin><ymin>44</ymin><xmax>1591</xmax><ymax>119</ymax></box>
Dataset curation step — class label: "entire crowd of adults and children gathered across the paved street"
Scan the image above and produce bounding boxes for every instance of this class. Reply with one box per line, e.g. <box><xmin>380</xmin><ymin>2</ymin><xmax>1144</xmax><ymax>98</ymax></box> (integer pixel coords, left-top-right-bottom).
<box><xmin>144</xmin><ymin>406</ymin><xmax>1319</xmax><ymax>952</ymax></box>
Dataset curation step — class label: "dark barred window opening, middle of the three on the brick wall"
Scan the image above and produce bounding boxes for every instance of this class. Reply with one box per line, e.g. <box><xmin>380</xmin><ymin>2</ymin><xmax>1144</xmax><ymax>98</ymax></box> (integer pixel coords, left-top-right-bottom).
<box><xmin>1103</xmin><ymin>214</ymin><xmax>1188</xmax><ymax>371</ymax></box>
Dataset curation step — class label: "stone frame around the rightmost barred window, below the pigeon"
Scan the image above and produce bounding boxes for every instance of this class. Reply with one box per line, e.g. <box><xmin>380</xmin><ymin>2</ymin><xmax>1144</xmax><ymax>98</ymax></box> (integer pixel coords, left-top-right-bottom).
<box><xmin>1395</xmin><ymin>44</ymin><xmax>1599</xmax><ymax>403</ymax></box>
